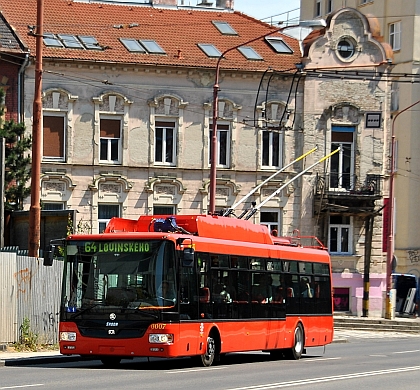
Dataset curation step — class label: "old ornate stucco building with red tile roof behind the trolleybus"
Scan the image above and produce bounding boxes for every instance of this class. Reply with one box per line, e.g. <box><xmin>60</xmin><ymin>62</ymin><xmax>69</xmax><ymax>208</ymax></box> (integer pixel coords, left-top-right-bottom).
<box><xmin>0</xmin><ymin>0</ymin><xmax>390</xmax><ymax>315</ymax></box>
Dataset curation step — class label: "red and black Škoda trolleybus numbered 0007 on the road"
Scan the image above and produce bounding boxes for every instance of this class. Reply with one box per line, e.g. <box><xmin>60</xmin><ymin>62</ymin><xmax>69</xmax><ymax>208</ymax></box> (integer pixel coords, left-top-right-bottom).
<box><xmin>54</xmin><ymin>215</ymin><xmax>333</xmax><ymax>366</ymax></box>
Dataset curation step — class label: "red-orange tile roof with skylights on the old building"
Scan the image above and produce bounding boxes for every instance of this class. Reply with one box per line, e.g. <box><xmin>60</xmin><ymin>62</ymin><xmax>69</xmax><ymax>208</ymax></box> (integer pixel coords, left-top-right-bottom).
<box><xmin>0</xmin><ymin>0</ymin><xmax>300</xmax><ymax>71</ymax></box>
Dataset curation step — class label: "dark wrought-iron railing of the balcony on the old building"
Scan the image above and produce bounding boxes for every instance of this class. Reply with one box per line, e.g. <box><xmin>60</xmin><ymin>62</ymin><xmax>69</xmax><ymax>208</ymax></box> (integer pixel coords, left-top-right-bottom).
<box><xmin>315</xmin><ymin>172</ymin><xmax>382</xmax><ymax>196</ymax></box>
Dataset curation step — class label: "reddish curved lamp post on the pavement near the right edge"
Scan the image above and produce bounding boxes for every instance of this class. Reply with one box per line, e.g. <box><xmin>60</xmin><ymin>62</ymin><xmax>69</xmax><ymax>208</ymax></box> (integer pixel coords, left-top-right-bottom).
<box><xmin>385</xmin><ymin>100</ymin><xmax>420</xmax><ymax>320</ymax></box>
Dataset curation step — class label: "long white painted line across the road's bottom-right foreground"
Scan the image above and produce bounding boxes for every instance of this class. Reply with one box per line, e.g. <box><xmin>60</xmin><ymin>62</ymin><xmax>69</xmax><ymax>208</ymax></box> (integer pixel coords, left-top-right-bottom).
<box><xmin>229</xmin><ymin>366</ymin><xmax>420</xmax><ymax>390</ymax></box>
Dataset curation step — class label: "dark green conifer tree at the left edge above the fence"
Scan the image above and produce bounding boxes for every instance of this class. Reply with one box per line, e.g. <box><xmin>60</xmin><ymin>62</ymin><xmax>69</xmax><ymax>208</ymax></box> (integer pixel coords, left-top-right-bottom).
<box><xmin>0</xmin><ymin>90</ymin><xmax>32</xmax><ymax>210</ymax></box>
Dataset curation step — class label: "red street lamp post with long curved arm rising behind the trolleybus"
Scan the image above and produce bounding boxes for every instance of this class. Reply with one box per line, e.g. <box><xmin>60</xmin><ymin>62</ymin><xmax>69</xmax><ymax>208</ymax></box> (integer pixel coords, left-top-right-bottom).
<box><xmin>209</xmin><ymin>19</ymin><xmax>326</xmax><ymax>214</ymax></box>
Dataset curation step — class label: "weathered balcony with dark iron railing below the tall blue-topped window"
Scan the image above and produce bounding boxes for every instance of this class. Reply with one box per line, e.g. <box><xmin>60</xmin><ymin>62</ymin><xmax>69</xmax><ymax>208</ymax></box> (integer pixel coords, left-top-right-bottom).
<box><xmin>314</xmin><ymin>172</ymin><xmax>383</xmax><ymax>215</ymax></box>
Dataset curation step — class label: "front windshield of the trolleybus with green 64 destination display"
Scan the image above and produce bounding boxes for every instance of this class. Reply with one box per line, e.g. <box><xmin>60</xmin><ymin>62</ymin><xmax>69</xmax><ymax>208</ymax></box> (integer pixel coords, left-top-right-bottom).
<box><xmin>62</xmin><ymin>240</ymin><xmax>177</xmax><ymax>319</ymax></box>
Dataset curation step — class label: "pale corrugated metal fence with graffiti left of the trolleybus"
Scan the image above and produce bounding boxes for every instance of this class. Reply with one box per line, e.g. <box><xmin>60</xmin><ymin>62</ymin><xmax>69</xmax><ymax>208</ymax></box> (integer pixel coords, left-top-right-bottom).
<box><xmin>0</xmin><ymin>252</ymin><xmax>63</xmax><ymax>344</ymax></box>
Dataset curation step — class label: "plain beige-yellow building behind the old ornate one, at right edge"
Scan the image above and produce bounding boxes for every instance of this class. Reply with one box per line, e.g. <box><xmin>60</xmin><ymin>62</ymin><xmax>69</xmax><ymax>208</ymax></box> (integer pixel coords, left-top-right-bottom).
<box><xmin>301</xmin><ymin>0</ymin><xmax>420</xmax><ymax>294</ymax></box>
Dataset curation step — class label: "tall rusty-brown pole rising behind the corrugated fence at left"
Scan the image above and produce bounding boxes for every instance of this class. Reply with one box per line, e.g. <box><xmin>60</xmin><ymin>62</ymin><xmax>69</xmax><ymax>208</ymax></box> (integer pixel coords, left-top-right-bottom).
<box><xmin>29</xmin><ymin>0</ymin><xmax>44</xmax><ymax>257</ymax></box>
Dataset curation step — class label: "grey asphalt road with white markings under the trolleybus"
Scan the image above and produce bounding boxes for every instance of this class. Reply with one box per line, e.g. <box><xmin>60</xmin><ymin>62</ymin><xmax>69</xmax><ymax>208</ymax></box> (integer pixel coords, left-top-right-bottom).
<box><xmin>0</xmin><ymin>332</ymin><xmax>420</xmax><ymax>390</ymax></box>
